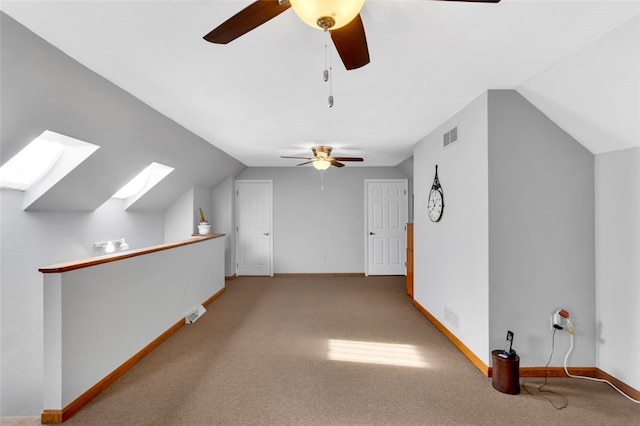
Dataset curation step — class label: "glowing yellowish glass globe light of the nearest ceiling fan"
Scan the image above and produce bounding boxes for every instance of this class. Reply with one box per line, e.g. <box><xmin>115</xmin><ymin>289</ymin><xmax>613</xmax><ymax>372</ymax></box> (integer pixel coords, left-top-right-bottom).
<box><xmin>290</xmin><ymin>0</ymin><xmax>365</xmax><ymax>30</ymax></box>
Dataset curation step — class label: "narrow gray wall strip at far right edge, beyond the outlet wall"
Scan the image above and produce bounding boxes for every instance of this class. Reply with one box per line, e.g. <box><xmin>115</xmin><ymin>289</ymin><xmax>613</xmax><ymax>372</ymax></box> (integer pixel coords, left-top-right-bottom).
<box><xmin>595</xmin><ymin>148</ymin><xmax>640</xmax><ymax>389</ymax></box>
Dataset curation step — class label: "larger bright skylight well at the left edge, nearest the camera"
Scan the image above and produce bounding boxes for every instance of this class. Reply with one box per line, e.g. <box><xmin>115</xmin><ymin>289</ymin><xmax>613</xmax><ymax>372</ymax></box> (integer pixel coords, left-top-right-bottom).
<box><xmin>0</xmin><ymin>130</ymin><xmax>100</xmax><ymax>209</ymax></box>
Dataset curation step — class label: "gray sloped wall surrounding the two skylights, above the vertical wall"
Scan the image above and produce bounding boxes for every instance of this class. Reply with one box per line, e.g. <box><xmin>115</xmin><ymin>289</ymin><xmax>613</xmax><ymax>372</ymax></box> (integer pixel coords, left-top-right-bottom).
<box><xmin>0</xmin><ymin>13</ymin><xmax>244</xmax><ymax>211</ymax></box>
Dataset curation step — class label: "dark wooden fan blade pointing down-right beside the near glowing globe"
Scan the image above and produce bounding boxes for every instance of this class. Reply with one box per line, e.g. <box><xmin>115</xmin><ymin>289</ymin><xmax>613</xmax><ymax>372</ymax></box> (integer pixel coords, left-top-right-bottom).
<box><xmin>331</xmin><ymin>15</ymin><xmax>369</xmax><ymax>70</ymax></box>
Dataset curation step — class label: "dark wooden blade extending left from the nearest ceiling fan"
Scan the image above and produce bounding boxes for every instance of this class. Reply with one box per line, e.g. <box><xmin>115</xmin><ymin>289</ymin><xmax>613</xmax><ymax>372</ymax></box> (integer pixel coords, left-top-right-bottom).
<box><xmin>203</xmin><ymin>0</ymin><xmax>291</xmax><ymax>44</ymax></box>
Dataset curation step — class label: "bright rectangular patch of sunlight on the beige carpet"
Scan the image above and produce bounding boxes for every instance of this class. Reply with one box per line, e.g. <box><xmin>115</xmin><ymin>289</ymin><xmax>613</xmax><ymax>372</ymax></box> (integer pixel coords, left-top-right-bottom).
<box><xmin>328</xmin><ymin>339</ymin><xmax>429</xmax><ymax>368</ymax></box>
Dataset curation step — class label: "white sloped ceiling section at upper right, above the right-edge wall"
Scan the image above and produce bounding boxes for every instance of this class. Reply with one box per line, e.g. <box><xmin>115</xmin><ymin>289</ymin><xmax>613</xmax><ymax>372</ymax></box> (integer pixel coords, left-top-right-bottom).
<box><xmin>518</xmin><ymin>15</ymin><xmax>640</xmax><ymax>154</ymax></box>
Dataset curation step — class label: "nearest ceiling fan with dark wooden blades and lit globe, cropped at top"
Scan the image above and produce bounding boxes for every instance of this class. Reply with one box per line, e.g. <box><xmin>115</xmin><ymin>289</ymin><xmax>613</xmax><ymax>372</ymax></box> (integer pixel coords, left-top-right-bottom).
<box><xmin>203</xmin><ymin>0</ymin><xmax>500</xmax><ymax>70</ymax></box>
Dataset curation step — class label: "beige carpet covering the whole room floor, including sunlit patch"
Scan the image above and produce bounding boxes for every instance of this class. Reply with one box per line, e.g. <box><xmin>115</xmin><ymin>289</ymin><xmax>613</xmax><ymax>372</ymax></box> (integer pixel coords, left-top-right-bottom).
<box><xmin>6</xmin><ymin>277</ymin><xmax>640</xmax><ymax>425</ymax></box>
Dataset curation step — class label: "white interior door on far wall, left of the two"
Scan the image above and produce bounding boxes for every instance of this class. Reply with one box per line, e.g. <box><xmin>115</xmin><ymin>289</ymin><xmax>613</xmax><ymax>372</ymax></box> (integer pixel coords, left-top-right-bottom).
<box><xmin>236</xmin><ymin>180</ymin><xmax>273</xmax><ymax>276</ymax></box>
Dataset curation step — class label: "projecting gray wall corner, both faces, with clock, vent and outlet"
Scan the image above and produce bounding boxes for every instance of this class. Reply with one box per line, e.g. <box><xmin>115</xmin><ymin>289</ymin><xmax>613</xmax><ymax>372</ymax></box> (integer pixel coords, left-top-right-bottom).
<box><xmin>414</xmin><ymin>90</ymin><xmax>596</xmax><ymax>367</ymax></box>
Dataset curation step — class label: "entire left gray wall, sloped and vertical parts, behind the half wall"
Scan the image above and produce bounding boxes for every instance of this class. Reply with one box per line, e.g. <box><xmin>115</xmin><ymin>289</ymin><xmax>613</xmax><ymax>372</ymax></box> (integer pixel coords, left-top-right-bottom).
<box><xmin>0</xmin><ymin>13</ymin><xmax>244</xmax><ymax>416</ymax></box>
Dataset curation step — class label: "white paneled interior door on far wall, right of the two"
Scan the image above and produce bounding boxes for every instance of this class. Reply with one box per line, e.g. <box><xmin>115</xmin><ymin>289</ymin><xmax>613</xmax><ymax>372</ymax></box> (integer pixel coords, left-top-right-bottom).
<box><xmin>365</xmin><ymin>179</ymin><xmax>408</xmax><ymax>275</ymax></box>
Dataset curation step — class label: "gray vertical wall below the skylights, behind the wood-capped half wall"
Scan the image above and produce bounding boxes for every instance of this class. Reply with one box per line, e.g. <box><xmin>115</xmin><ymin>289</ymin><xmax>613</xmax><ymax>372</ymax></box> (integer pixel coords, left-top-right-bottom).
<box><xmin>0</xmin><ymin>190</ymin><xmax>164</xmax><ymax>416</ymax></box>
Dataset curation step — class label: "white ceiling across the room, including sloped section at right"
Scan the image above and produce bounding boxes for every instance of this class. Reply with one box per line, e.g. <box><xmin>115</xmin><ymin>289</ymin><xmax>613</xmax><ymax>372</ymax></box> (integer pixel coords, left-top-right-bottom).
<box><xmin>1</xmin><ymin>0</ymin><xmax>640</xmax><ymax>167</ymax></box>
